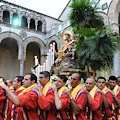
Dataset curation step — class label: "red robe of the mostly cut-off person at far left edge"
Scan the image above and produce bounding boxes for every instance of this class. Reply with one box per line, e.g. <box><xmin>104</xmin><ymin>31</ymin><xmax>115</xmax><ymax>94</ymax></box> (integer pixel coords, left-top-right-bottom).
<box><xmin>0</xmin><ymin>87</ymin><xmax>7</xmax><ymax>120</ymax></box>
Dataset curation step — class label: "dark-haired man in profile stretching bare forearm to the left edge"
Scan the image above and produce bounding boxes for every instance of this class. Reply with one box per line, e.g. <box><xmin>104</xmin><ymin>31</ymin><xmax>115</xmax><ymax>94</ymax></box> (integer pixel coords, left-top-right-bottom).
<box><xmin>0</xmin><ymin>73</ymin><xmax>40</xmax><ymax>120</ymax></box>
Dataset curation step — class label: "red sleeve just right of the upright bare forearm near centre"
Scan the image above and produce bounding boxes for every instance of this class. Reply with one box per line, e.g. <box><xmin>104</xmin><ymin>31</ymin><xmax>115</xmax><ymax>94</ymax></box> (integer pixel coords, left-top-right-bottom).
<box><xmin>60</xmin><ymin>93</ymin><xmax>70</xmax><ymax>109</ymax></box>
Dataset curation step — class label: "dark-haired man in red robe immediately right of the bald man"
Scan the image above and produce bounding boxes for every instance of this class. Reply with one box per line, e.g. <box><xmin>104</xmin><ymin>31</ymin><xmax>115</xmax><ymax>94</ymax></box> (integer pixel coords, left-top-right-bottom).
<box><xmin>97</xmin><ymin>77</ymin><xmax>115</xmax><ymax>120</ymax></box>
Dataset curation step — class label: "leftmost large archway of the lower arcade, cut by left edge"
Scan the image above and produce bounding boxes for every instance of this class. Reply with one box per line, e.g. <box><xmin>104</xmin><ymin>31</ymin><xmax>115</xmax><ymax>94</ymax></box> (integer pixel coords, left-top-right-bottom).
<box><xmin>0</xmin><ymin>34</ymin><xmax>21</xmax><ymax>80</ymax></box>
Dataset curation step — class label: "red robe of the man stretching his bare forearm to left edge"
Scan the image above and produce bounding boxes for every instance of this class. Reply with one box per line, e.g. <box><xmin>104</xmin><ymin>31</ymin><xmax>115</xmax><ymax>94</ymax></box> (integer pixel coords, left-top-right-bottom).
<box><xmin>19</xmin><ymin>90</ymin><xmax>40</xmax><ymax>120</ymax></box>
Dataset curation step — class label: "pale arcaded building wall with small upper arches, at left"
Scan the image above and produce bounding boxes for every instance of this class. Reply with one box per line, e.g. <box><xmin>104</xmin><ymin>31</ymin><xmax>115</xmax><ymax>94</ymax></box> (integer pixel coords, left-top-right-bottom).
<box><xmin>0</xmin><ymin>0</ymin><xmax>61</xmax><ymax>80</ymax></box>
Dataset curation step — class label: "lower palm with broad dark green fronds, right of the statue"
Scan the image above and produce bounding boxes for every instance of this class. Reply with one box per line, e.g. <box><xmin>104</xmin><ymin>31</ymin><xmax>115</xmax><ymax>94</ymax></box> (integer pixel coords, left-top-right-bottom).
<box><xmin>76</xmin><ymin>26</ymin><xmax>117</xmax><ymax>77</ymax></box>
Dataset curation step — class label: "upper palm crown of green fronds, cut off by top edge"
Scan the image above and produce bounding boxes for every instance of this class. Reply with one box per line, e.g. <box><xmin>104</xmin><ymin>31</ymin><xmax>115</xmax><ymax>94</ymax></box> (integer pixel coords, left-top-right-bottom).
<box><xmin>68</xmin><ymin>0</ymin><xmax>104</xmax><ymax>32</ymax></box>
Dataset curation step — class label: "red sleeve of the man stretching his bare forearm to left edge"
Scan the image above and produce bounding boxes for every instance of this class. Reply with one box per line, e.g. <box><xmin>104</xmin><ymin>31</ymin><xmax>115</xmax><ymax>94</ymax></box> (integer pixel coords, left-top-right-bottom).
<box><xmin>19</xmin><ymin>90</ymin><xmax>38</xmax><ymax>109</ymax></box>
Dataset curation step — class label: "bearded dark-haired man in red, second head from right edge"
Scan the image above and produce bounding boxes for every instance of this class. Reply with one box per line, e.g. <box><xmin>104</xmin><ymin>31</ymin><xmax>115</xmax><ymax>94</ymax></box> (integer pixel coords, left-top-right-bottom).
<box><xmin>109</xmin><ymin>76</ymin><xmax>120</xmax><ymax>120</ymax></box>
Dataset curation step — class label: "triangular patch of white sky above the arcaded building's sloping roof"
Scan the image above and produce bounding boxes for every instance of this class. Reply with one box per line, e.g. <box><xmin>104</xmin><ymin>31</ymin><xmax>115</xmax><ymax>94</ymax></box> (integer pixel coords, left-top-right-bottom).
<box><xmin>6</xmin><ymin>0</ymin><xmax>69</xmax><ymax>18</ymax></box>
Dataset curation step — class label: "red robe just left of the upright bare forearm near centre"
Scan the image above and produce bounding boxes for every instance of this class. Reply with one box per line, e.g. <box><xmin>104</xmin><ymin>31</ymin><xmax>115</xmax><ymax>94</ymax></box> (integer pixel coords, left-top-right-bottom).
<box><xmin>38</xmin><ymin>89</ymin><xmax>56</xmax><ymax>120</ymax></box>
